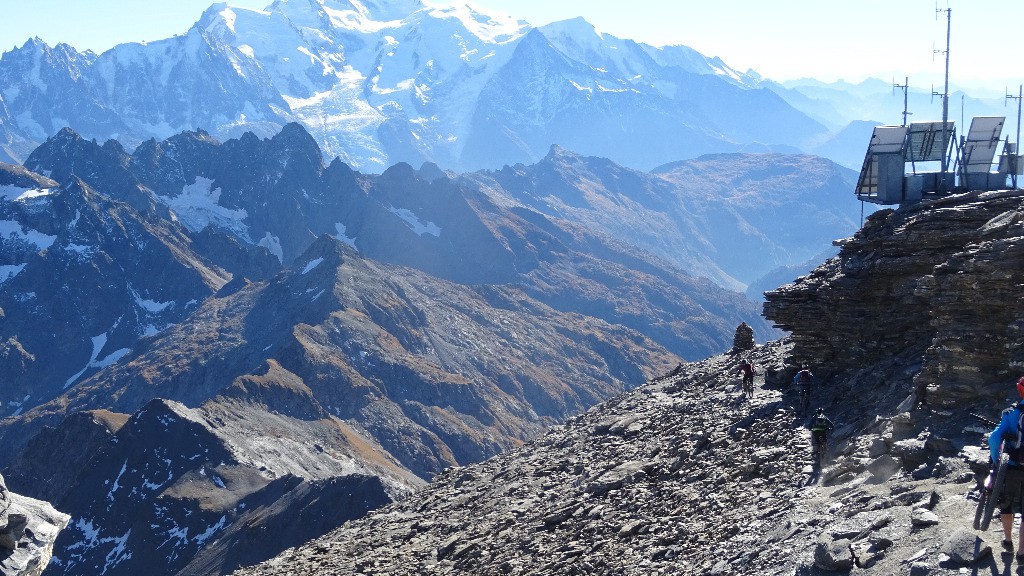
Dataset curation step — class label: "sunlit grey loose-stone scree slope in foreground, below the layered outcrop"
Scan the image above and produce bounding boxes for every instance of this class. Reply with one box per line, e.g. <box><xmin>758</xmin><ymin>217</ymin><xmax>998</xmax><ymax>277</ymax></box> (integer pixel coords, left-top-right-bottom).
<box><xmin>226</xmin><ymin>344</ymin><xmax>991</xmax><ymax>576</ymax></box>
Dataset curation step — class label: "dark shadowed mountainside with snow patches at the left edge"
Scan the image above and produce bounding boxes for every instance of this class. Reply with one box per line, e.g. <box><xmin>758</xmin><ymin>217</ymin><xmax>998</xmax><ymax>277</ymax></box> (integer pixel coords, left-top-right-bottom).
<box><xmin>0</xmin><ymin>155</ymin><xmax>274</xmax><ymax>415</ymax></box>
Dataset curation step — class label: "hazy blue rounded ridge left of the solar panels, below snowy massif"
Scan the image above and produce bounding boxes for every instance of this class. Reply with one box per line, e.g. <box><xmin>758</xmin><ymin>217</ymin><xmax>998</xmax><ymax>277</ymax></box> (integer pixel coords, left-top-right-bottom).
<box><xmin>461</xmin><ymin>147</ymin><xmax>860</xmax><ymax>289</ymax></box>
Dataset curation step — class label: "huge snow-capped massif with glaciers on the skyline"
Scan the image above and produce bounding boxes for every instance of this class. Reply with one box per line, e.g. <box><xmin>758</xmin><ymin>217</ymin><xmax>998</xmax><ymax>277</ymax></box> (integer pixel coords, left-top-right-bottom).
<box><xmin>0</xmin><ymin>0</ymin><xmax>824</xmax><ymax>172</ymax></box>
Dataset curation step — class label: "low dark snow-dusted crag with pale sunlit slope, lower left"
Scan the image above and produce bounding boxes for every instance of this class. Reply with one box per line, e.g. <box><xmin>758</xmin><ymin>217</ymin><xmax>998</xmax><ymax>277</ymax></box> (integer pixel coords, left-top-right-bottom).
<box><xmin>36</xmin><ymin>391</ymin><xmax>422</xmax><ymax>575</ymax></box>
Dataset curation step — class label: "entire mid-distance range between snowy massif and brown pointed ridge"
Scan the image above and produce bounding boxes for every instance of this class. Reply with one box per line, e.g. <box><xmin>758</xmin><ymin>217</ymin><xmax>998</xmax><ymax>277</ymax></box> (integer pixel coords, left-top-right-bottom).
<box><xmin>6</xmin><ymin>124</ymin><xmax>854</xmax><ymax>422</ymax></box>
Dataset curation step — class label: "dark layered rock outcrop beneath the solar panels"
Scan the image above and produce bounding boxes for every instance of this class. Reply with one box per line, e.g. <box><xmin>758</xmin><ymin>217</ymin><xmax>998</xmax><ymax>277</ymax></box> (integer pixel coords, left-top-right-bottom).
<box><xmin>764</xmin><ymin>191</ymin><xmax>1024</xmax><ymax>408</ymax></box>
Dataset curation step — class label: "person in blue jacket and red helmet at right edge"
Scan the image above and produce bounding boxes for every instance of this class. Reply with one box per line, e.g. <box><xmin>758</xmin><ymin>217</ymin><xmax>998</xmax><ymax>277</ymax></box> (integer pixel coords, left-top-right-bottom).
<box><xmin>988</xmin><ymin>376</ymin><xmax>1024</xmax><ymax>563</ymax></box>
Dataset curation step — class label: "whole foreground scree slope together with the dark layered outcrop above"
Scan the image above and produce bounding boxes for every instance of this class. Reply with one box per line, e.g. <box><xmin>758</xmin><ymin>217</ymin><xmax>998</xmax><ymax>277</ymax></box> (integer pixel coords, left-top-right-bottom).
<box><xmin>230</xmin><ymin>191</ymin><xmax>1024</xmax><ymax>576</ymax></box>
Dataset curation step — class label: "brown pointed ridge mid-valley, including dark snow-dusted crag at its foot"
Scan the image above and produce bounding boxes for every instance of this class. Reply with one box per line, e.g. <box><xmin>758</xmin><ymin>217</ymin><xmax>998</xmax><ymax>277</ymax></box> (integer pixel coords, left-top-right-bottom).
<box><xmin>0</xmin><ymin>237</ymin><xmax>678</xmax><ymax>575</ymax></box>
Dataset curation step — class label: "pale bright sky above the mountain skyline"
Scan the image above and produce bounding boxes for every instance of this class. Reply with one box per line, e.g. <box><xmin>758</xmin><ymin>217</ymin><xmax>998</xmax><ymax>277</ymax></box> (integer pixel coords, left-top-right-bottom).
<box><xmin>0</xmin><ymin>0</ymin><xmax>1024</xmax><ymax>93</ymax></box>
